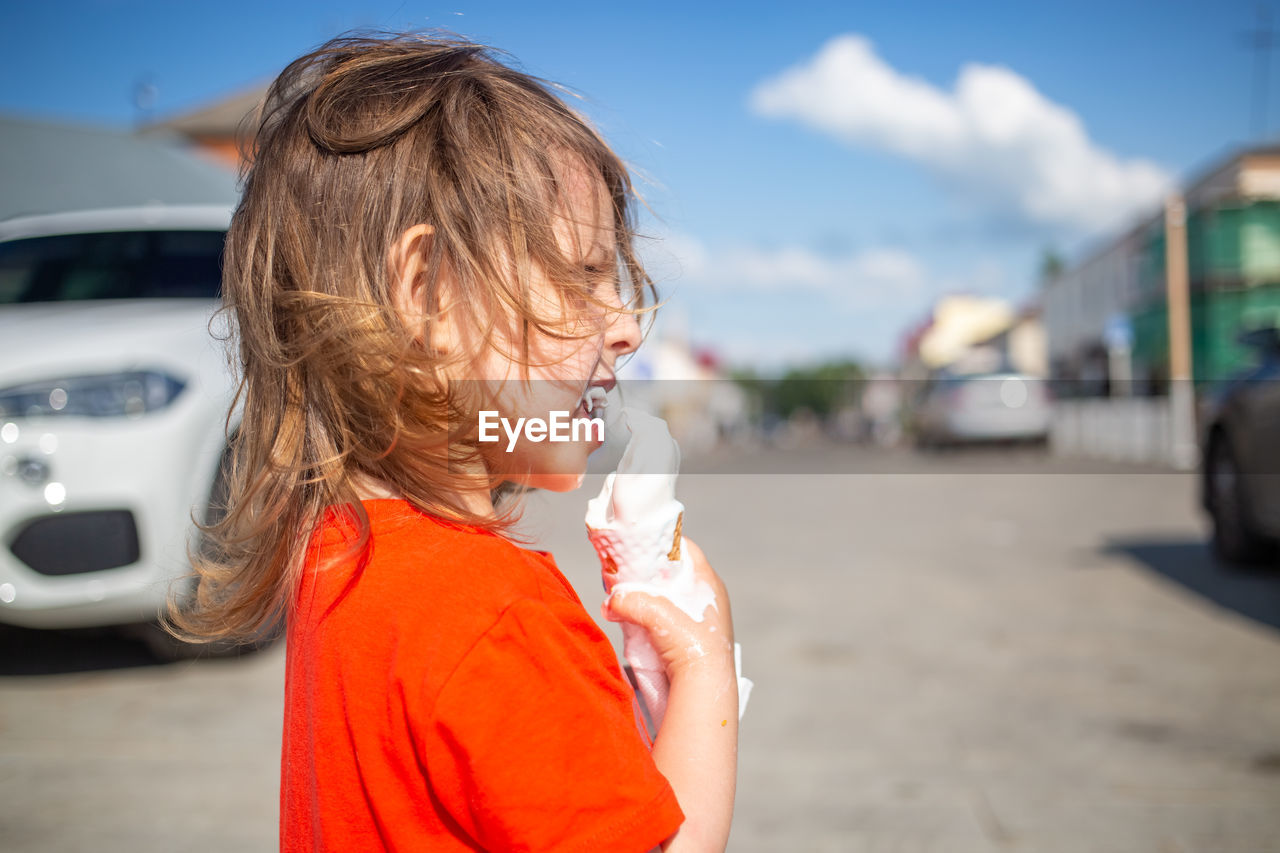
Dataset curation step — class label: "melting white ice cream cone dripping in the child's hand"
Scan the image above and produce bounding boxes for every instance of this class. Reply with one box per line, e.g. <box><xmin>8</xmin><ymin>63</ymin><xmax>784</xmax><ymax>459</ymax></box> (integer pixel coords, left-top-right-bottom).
<box><xmin>586</xmin><ymin>407</ymin><xmax>751</xmax><ymax>727</ymax></box>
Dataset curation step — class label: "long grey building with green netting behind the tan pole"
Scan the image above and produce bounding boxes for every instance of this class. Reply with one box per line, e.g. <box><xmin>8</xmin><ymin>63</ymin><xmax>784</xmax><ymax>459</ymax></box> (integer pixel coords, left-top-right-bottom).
<box><xmin>1043</xmin><ymin>147</ymin><xmax>1280</xmax><ymax>397</ymax></box>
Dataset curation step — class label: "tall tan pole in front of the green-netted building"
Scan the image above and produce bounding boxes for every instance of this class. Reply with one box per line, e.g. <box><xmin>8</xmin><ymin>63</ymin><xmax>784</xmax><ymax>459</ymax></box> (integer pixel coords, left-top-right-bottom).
<box><xmin>1165</xmin><ymin>192</ymin><xmax>1199</xmax><ymax>471</ymax></box>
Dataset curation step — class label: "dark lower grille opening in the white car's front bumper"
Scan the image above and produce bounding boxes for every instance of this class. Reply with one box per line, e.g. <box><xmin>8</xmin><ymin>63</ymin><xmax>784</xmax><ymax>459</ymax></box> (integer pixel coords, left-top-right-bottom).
<box><xmin>9</xmin><ymin>510</ymin><xmax>138</xmax><ymax>575</ymax></box>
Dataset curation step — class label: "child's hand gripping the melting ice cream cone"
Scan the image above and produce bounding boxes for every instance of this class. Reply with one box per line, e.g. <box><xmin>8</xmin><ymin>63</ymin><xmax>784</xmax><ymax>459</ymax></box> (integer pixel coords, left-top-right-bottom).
<box><xmin>603</xmin><ymin>537</ymin><xmax>733</xmax><ymax>681</ymax></box>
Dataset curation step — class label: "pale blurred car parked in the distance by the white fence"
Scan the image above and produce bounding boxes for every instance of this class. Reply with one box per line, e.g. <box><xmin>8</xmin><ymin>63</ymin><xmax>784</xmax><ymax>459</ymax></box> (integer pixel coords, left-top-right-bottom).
<box><xmin>915</xmin><ymin>373</ymin><xmax>1051</xmax><ymax>448</ymax></box>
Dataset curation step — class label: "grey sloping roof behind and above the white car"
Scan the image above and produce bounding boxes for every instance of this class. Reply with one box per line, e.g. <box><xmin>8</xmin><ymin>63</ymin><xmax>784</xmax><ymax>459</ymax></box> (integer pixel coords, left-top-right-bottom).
<box><xmin>0</xmin><ymin>115</ymin><xmax>239</xmax><ymax>219</ymax></box>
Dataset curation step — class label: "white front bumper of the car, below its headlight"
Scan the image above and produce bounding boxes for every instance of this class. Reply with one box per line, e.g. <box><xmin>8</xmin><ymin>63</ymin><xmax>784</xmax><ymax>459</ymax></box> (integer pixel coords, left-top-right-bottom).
<box><xmin>0</xmin><ymin>400</ymin><xmax>224</xmax><ymax>628</ymax></box>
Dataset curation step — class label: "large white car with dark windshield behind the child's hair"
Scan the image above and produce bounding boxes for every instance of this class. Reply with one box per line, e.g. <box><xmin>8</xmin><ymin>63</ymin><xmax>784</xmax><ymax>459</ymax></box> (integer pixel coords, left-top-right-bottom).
<box><xmin>0</xmin><ymin>206</ymin><xmax>234</xmax><ymax>628</ymax></box>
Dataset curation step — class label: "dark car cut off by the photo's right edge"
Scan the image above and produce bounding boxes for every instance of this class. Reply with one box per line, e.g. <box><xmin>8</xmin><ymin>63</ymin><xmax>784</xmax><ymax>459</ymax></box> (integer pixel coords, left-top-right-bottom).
<box><xmin>1201</xmin><ymin>329</ymin><xmax>1280</xmax><ymax>564</ymax></box>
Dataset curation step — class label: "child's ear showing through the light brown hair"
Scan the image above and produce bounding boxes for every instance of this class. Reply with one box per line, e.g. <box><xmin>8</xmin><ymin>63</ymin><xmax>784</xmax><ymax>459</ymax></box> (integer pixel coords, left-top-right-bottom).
<box><xmin>387</xmin><ymin>223</ymin><xmax>461</xmax><ymax>355</ymax></box>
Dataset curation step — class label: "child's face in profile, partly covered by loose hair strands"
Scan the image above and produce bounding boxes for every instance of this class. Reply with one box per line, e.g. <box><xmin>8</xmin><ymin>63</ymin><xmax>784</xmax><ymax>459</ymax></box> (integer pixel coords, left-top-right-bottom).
<box><xmin>475</xmin><ymin>169</ymin><xmax>640</xmax><ymax>492</ymax></box>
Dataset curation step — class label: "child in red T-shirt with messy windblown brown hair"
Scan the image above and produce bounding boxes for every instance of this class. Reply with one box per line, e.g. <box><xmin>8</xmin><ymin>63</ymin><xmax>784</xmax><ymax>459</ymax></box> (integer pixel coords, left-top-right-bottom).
<box><xmin>172</xmin><ymin>36</ymin><xmax>737</xmax><ymax>850</ymax></box>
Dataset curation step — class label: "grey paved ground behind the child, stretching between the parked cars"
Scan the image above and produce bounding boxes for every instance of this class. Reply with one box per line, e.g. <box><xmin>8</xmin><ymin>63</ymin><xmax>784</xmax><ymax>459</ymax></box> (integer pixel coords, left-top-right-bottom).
<box><xmin>0</xmin><ymin>447</ymin><xmax>1280</xmax><ymax>853</ymax></box>
